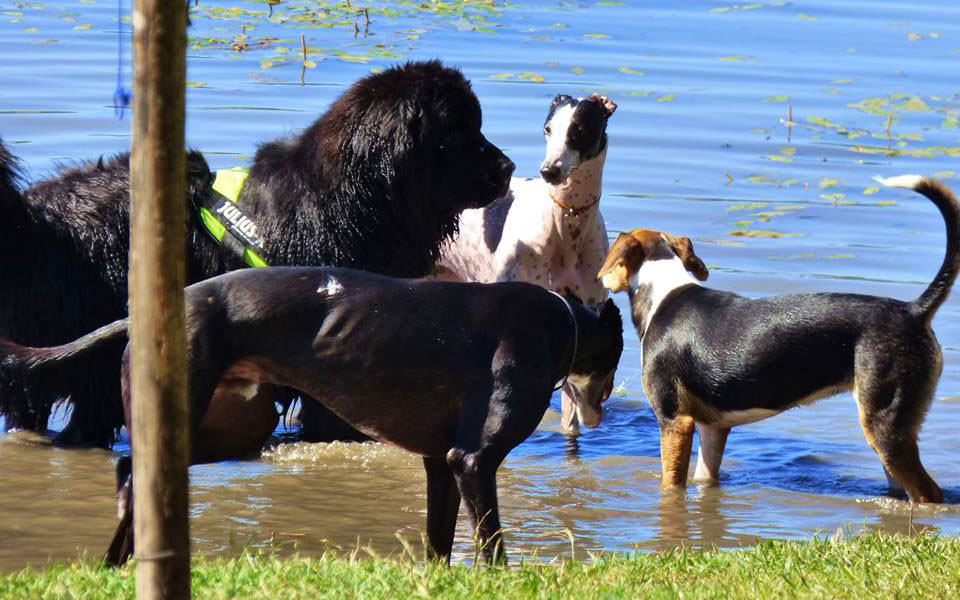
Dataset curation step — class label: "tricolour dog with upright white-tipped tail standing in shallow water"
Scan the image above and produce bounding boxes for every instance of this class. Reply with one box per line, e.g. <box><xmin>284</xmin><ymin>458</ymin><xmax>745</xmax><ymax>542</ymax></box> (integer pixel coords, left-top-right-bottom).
<box><xmin>598</xmin><ymin>175</ymin><xmax>960</xmax><ymax>502</ymax></box>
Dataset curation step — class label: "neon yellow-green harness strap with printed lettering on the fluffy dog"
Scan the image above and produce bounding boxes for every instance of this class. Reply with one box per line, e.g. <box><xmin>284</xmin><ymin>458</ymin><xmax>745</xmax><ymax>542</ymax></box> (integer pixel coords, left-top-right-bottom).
<box><xmin>200</xmin><ymin>169</ymin><xmax>268</xmax><ymax>267</ymax></box>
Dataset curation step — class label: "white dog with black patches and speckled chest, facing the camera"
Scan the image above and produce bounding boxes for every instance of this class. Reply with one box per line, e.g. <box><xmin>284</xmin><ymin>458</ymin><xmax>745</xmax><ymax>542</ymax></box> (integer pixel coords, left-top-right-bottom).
<box><xmin>438</xmin><ymin>94</ymin><xmax>617</xmax><ymax>433</ymax></box>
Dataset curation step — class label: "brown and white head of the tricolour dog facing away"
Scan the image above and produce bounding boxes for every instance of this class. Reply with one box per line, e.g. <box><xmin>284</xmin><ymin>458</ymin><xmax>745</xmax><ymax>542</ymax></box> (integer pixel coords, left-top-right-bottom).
<box><xmin>597</xmin><ymin>229</ymin><xmax>709</xmax><ymax>336</ymax></box>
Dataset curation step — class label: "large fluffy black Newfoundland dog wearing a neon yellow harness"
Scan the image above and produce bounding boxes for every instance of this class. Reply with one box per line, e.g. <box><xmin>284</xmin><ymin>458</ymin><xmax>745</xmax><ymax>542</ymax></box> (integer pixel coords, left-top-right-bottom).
<box><xmin>0</xmin><ymin>61</ymin><xmax>514</xmax><ymax>451</ymax></box>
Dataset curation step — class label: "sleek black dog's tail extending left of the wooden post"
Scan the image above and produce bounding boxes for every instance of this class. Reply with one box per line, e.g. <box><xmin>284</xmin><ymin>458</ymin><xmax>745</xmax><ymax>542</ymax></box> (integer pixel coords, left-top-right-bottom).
<box><xmin>0</xmin><ymin>319</ymin><xmax>127</xmax><ymax>415</ymax></box>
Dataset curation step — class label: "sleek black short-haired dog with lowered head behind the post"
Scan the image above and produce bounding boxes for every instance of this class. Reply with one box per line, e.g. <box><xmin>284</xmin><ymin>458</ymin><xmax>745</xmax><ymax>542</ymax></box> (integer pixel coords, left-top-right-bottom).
<box><xmin>0</xmin><ymin>267</ymin><xmax>623</xmax><ymax>564</ymax></box>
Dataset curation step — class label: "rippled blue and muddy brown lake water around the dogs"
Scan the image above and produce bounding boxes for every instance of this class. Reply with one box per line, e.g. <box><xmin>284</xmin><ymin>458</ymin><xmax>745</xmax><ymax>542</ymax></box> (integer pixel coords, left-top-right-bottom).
<box><xmin>0</xmin><ymin>0</ymin><xmax>960</xmax><ymax>569</ymax></box>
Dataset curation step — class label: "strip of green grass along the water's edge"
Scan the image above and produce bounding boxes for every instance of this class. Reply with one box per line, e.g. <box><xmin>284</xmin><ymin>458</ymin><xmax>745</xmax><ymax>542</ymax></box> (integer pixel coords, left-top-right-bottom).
<box><xmin>0</xmin><ymin>535</ymin><xmax>960</xmax><ymax>600</ymax></box>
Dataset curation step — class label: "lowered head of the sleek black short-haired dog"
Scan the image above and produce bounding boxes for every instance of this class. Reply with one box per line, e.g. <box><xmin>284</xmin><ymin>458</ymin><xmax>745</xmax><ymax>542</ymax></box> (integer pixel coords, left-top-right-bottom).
<box><xmin>567</xmin><ymin>298</ymin><xmax>623</xmax><ymax>427</ymax></box>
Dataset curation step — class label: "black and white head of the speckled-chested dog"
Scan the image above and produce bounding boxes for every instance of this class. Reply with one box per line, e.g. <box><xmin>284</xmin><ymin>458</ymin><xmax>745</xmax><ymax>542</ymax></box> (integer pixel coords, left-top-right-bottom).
<box><xmin>540</xmin><ymin>94</ymin><xmax>617</xmax><ymax>185</ymax></box>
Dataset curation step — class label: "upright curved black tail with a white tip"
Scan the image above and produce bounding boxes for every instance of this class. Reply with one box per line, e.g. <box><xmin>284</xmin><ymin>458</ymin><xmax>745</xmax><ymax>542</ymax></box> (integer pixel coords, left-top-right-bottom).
<box><xmin>875</xmin><ymin>175</ymin><xmax>960</xmax><ymax>323</ymax></box>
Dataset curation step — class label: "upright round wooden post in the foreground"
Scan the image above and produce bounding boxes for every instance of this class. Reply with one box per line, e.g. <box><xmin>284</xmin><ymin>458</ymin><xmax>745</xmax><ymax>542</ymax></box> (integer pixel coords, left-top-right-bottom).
<box><xmin>129</xmin><ymin>0</ymin><xmax>190</xmax><ymax>600</ymax></box>
